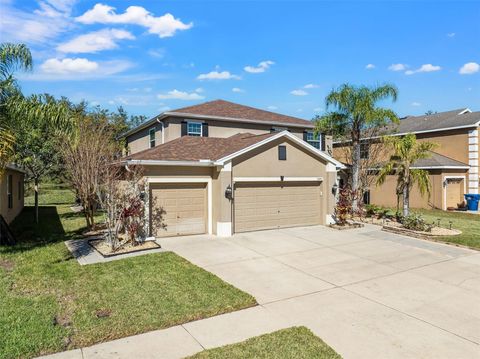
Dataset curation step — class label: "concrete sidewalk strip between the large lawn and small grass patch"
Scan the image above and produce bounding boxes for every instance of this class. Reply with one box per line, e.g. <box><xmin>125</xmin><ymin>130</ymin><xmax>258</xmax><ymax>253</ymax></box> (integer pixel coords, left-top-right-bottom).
<box><xmin>41</xmin><ymin>306</ymin><xmax>289</xmax><ymax>359</ymax></box>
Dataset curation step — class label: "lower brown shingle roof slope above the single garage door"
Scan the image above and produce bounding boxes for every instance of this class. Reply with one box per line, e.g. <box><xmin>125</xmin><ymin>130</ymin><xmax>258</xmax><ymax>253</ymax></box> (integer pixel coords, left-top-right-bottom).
<box><xmin>125</xmin><ymin>133</ymin><xmax>275</xmax><ymax>161</ymax></box>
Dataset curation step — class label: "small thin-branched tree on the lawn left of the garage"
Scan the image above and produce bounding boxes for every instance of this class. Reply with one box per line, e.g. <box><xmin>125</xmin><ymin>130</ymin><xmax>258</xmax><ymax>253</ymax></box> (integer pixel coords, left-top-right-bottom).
<box><xmin>60</xmin><ymin>112</ymin><xmax>120</xmax><ymax>229</ymax></box>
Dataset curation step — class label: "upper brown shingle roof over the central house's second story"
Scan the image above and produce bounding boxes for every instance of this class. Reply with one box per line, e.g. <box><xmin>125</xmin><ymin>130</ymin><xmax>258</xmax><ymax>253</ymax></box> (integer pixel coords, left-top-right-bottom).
<box><xmin>168</xmin><ymin>100</ymin><xmax>313</xmax><ymax>127</ymax></box>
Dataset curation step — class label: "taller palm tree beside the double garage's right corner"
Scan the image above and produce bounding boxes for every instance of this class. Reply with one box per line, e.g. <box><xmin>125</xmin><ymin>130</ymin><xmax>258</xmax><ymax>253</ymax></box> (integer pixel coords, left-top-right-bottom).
<box><xmin>316</xmin><ymin>84</ymin><xmax>398</xmax><ymax>210</ymax></box>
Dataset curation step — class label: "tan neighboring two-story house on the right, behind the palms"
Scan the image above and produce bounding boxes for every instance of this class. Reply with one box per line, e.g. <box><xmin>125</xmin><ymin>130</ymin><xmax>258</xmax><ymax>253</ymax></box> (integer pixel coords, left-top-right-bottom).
<box><xmin>334</xmin><ymin>108</ymin><xmax>480</xmax><ymax>210</ymax></box>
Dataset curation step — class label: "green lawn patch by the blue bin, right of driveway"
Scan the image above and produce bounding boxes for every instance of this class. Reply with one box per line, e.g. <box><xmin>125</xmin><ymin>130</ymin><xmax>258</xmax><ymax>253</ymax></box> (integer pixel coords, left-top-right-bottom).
<box><xmin>414</xmin><ymin>209</ymin><xmax>480</xmax><ymax>249</ymax></box>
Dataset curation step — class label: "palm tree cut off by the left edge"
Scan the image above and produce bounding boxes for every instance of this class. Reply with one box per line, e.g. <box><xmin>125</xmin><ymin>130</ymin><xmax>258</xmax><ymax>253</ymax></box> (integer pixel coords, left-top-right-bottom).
<box><xmin>0</xmin><ymin>43</ymin><xmax>32</xmax><ymax>175</ymax></box>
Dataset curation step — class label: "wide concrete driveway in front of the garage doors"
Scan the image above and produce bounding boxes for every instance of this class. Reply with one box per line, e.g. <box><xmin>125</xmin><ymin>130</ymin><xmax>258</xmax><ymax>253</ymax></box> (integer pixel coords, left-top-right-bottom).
<box><xmin>161</xmin><ymin>226</ymin><xmax>480</xmax><ymax>358</ymax></box>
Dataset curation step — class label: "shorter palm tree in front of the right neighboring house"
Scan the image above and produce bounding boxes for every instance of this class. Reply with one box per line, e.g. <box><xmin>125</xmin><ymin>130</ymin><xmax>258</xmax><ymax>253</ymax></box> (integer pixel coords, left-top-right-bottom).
<box><xmin>377</xmin><ymin>133</ymin><xmax>436</xmax><ymax>217</ymax></box>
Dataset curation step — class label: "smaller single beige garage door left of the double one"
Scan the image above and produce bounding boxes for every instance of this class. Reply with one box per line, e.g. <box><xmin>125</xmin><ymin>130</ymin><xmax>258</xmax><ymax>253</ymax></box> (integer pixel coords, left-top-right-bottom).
<box><xmin>150</xmin><ymin>183</ymin><xmax>207</xmax><ymax>237</ymax></box>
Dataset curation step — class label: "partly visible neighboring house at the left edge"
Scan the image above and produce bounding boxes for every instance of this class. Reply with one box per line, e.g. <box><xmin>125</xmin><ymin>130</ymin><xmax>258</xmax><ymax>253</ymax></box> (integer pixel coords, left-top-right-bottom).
<box><xmin>0</xmin><ymin>165</ymin><xmax>25</xmax><ymax>223</ymax></box>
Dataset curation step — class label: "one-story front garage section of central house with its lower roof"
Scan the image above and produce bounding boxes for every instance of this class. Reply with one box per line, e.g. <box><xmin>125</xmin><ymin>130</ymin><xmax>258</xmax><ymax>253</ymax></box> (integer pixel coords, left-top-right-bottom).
<box><xmin>123</xmin><ymin>131</ymin><xmax>343</xmax><ymax>237</ymax></box>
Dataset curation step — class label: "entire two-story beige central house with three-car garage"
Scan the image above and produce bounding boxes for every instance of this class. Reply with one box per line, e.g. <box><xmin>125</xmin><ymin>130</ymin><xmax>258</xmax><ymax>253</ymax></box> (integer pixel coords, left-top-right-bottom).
<box><xmin>123</xmin><ymin>101</ymin><xmax>343</xmax><ymax>237</ymax></box>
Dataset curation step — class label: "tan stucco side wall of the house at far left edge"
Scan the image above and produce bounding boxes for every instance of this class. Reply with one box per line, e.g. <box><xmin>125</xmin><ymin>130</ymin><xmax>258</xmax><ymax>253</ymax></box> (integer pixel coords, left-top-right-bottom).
<box><xmin>0</xmin><ymin>169</ymin><xmax>25</xmax><ymax>223</ymax></box>
